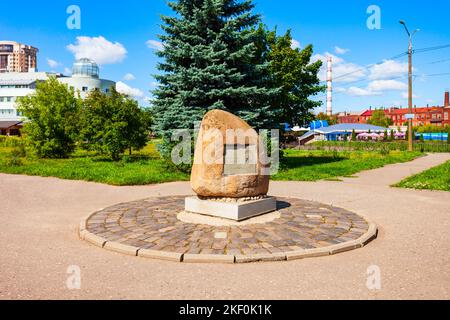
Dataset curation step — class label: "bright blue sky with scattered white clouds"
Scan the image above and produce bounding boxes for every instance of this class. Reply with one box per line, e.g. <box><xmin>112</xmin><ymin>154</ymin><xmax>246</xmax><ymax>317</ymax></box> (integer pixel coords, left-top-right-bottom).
<box><xmin>0</xmin><ymin>0</ymin><xmax>450</xmax><ymax>111</ymax></box>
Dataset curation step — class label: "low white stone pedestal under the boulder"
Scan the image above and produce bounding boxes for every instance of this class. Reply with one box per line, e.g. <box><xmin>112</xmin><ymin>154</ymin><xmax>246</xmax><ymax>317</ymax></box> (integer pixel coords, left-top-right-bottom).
<box><xmin>185</xmin><ymin>197</ymin><xmax>277</xmax><ymax>221</ymax></box>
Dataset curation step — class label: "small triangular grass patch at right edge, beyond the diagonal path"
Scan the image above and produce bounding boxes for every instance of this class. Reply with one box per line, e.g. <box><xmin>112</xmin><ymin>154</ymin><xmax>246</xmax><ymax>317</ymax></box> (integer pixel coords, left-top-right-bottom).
<box><xmin>395</xmin><ymin>161</ymin><xmax>450</xmax><ymax>191</ymax></box>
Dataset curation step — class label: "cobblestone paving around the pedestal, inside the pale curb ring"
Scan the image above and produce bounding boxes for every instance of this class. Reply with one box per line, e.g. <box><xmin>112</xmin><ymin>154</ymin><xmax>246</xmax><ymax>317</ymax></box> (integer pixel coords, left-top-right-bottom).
<box><xmin>87</xmin><ymin>197</ymin><xmax>369</xmax><ymax>255</ymax></box>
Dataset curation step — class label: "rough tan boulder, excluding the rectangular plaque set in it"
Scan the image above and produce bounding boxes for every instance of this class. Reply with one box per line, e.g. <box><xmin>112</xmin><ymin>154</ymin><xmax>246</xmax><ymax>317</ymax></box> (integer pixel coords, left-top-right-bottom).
<box><xmin>191</xmin><ymin>110</ymin><xmax>269</xmax><ymax>198</ymax></box>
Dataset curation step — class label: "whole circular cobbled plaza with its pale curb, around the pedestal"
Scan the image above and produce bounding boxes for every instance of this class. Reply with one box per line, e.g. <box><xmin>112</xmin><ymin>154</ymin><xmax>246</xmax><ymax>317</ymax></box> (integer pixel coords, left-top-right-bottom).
<box><xmin>80</xmin><ymin>197</ymin><xmax>377</xmax><ymax>263</ymax></box>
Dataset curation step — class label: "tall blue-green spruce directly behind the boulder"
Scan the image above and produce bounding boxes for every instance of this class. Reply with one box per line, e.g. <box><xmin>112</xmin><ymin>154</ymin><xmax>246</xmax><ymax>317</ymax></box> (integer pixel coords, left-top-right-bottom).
<box><xmin>154</xmin><ymin>0</ymin><xmax>279</xmax><ymax>156</ymax></box>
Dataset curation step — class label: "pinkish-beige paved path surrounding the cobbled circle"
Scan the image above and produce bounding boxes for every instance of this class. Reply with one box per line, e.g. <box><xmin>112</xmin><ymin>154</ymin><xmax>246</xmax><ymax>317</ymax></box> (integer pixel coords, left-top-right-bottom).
<box><xmin>0</xmin><ymin>154</ymin><xmax>450</xmax><ymax>300</ymax></box>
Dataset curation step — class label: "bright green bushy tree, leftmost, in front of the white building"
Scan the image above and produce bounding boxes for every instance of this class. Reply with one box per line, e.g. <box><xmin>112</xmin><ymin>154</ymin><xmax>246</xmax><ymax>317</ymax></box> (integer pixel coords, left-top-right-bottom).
<box><xmin>17</xmin><ymin>77</ymin><xmax>81</xmax><ymax>158</ymax></box>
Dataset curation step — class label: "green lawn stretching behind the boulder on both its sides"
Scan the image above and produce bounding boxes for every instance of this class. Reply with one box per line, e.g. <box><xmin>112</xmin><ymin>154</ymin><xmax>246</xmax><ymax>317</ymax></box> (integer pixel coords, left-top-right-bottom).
<box><xmin>0</xmin><ymin>142</ymin><xmax>421</xmax><ymax>186</ymax></box>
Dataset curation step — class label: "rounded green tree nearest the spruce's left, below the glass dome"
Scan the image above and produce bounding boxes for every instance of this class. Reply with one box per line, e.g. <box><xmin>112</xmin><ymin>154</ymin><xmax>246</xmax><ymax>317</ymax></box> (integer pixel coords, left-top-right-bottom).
<box><xmin>80</xmin><ymin>88</ymin><xmax>151</xmax><ymax>161</ymax></box>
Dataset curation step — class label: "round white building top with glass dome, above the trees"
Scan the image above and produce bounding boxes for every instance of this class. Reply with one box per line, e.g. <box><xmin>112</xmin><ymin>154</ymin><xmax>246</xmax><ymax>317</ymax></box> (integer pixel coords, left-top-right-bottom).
<box><xmin>58</xmin><ymin>58</ymin><xmax>116</xmax><ymax>99</ymax></box>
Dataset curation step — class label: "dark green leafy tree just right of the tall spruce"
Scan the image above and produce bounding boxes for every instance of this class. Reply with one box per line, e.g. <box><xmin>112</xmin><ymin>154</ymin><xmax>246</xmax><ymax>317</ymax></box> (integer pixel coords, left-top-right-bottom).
<box><xmin>267</xmin><ymin>30</ymin><xmax>326</xmax><ymax>126</ymax></box>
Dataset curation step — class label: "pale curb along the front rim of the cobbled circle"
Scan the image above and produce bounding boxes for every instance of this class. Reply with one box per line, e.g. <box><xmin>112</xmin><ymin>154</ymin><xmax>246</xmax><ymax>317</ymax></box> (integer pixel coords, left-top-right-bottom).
<box><xmin>79</xmin><ymin>209</ymin><xmax>378</xmax><ymax>264</ymax></box>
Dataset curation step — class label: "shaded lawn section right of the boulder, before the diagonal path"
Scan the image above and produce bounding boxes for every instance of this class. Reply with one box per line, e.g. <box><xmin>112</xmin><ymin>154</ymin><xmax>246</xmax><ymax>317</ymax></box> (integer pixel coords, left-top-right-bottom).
<box><xmin>273</xmin><ymin>150</ymin><xmax>422</xmax><ymax>181</ymax></box>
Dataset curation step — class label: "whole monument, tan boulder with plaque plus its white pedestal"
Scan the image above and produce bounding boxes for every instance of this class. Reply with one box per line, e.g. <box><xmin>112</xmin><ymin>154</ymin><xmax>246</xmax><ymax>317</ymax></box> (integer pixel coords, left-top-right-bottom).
<box><xmin>186</xmin><ymin>110</ymin><xmax>277</xmax><ymax>221</ymax></box>
